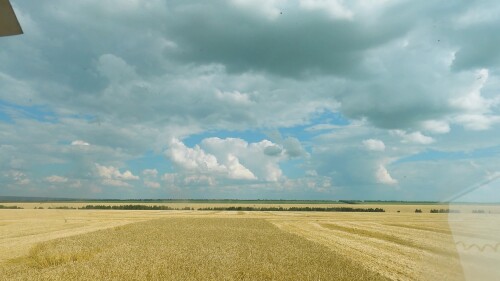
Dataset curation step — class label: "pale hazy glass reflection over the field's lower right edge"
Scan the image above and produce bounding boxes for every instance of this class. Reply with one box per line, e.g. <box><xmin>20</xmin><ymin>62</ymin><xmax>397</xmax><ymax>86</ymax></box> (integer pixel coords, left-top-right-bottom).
<box><xmin>445</xmin><ymin>172</ymin><xmax>500</xmax><ymax>280</ymax></box>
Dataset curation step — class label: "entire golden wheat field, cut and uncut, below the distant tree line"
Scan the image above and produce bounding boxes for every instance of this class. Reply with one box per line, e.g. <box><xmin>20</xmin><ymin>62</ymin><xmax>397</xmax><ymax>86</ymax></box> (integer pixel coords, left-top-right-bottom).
<box><xmin>0</xmin><ymin>203</ymin><xmax>500</xmax><ymax>280</ymax></box>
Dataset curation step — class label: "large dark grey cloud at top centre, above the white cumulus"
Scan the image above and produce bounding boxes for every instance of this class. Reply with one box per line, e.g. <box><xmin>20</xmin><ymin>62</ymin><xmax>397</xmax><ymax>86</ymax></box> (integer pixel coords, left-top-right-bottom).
<box><xmin>162</xmin><ymin>0</ymin><xmax>415</xmax><ymax>76</ymax></box>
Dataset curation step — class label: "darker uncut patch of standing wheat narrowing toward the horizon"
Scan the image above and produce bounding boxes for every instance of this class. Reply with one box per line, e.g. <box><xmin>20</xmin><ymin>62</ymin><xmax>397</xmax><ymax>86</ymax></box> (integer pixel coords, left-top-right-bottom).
<box><xmin>0</xmin><ymin>218</ymin><xmax>385</xmax><ymax>280</ymax></box>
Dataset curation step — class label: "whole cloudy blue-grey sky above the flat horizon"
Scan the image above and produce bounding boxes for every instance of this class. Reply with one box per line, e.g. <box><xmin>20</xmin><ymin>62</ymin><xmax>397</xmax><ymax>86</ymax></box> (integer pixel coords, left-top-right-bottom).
<box><xmin>0</xmin><ymin>0</ymin><xmax>500</xmax><ymax>201</ymax></box>
